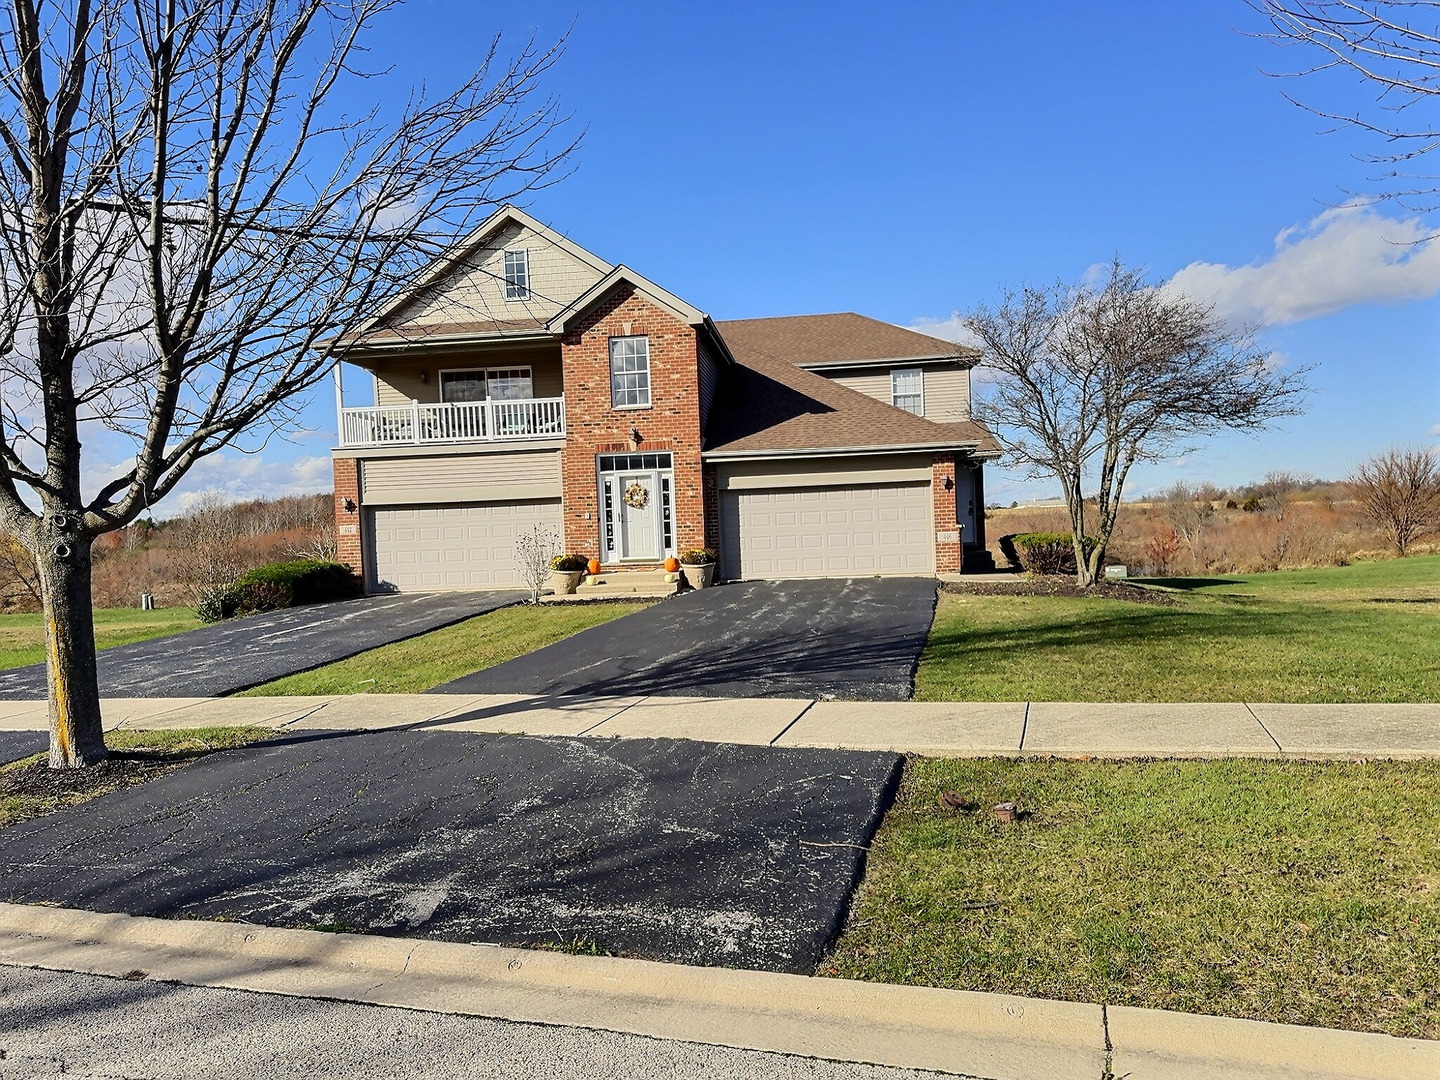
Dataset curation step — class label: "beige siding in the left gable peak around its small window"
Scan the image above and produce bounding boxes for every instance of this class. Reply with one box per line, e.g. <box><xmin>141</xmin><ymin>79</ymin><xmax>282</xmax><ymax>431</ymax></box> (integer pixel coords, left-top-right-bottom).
<box><xmin>385</xmin><ymin>222</ymin><xmax>605</xmax><ymax>325</ymax></box>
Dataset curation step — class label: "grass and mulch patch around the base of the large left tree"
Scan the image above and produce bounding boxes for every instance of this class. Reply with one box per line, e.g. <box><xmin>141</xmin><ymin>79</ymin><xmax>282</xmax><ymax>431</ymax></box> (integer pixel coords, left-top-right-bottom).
<box><xmin>0</xmin><ymin>727</ymin><xmax>274</xmax><ymax>828</ymax></box>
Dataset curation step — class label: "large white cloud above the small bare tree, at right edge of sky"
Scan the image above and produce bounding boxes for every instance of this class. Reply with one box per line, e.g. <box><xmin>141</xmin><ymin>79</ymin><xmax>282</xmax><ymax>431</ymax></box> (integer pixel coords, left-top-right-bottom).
<box><xmin>1169</xmin><ymin>204</ymin><xmax>1440</xmax><ymax>325</ymax></box>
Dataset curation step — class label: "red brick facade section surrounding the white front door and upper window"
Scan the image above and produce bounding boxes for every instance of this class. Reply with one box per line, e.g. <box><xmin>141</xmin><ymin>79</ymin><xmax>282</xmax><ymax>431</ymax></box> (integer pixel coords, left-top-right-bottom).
<box><xmin>560</xmin><ymin>285</ymin><xmax>708</xmax><ymax>567</ymax></box>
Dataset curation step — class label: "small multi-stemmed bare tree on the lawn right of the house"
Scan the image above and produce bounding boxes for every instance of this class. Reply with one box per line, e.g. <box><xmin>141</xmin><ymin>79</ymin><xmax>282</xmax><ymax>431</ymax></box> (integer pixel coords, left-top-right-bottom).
<box><xmin>965</xmin><ymin>261</ymin><xmax>1305</xmax><ymax>586</ymax></box>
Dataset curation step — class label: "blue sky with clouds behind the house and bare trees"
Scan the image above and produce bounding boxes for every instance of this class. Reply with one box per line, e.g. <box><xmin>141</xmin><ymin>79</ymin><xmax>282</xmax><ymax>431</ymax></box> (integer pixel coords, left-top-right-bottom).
<box><xmin>174</xmin><ymin>0</ymin><xmax>1440</xmax><ymax>503</ymax></box>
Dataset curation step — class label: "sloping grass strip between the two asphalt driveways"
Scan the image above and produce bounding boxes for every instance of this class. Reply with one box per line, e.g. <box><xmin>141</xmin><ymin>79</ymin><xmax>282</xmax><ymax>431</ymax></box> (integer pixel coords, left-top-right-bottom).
<box><xmin>245</xmin><ymin>603</ymin><xmax>648</xmax><ymax>697</ymax></box>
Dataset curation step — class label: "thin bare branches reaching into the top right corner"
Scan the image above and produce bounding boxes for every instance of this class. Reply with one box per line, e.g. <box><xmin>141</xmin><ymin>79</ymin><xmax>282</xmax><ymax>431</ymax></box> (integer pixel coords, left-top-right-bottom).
<box><xmin>1251</xmin><ymin>0</ymin><xmax>1440</xmax><ymax>210</ymax></box>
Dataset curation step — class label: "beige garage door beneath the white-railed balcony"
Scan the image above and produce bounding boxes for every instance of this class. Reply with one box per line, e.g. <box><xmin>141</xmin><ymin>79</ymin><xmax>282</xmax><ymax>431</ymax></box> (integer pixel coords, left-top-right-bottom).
<box><xmin>369</xmin><ymin>500</ymin><xmax>560</xmax><ymax>592</ymax></box>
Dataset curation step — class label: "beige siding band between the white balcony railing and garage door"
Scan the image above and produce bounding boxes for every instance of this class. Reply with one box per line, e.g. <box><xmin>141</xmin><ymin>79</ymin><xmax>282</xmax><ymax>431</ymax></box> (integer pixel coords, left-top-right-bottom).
<box><xmin>360</xmin><ymin>449</ymin><xmax>560</xmax><ymax>505</ymax></box>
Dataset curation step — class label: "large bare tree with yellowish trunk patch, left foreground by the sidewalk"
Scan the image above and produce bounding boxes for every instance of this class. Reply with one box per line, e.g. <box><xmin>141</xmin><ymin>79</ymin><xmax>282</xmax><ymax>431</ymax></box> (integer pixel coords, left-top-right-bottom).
<box><xmin>0</xmin><ymin>0</ymin><xmax>573</xmax><ymax>768</ymax></box>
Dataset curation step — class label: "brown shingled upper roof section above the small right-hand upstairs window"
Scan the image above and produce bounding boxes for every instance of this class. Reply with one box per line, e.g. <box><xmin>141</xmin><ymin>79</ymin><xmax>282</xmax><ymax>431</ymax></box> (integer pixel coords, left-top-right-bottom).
<box><xmin>720</xmin><ymin>311</ymin><xmax>981</xmax><ymax>369</ymax></box>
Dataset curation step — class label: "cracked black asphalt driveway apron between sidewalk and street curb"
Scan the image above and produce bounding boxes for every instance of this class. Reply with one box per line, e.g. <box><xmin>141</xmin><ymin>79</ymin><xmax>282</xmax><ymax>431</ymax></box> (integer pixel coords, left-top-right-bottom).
<box><xmin>0</xmin><ymin>730</ymin><xmax>901</xmax><ymax>973</ymax></box>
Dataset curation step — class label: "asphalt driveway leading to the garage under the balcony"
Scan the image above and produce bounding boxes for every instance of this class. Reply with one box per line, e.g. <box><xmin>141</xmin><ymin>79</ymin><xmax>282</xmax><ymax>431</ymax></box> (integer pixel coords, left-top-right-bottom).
<box><xmin>0</xmin><ymin>592</ymin><xmax>524</xmax><ymax>698</ymax></box>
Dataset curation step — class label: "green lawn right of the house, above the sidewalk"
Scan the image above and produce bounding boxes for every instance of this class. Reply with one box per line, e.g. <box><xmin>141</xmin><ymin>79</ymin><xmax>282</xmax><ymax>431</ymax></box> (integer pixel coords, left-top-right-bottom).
<box><xmin>916</xmin><ymin>557</ymin><xmax>1440</xmax><ymax>703</ymax></box>
